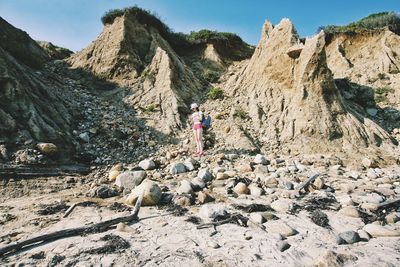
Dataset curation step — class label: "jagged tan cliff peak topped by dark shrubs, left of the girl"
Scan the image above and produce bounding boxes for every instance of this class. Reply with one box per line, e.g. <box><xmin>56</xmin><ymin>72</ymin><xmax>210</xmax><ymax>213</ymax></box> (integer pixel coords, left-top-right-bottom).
<box><xmin>68</xmin><ymin>14</ymin><xmax>202</xmax><ymax>133</ymax></box>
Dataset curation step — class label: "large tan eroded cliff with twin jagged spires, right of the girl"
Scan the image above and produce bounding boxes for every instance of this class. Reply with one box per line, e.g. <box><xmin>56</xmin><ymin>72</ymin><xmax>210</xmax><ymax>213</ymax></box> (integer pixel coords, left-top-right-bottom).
<box><xmin>224</xmin><ymin>19</ymin><xmax>392</xmax><ymax>161</ymax></box>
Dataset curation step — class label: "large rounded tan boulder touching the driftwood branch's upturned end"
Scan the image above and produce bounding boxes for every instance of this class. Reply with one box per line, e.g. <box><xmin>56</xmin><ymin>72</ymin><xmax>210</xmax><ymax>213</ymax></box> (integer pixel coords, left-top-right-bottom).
<box><xmin>126</xmin><ymin>180</ymin><xmax>162</xmax><ymax>206</ymax></box>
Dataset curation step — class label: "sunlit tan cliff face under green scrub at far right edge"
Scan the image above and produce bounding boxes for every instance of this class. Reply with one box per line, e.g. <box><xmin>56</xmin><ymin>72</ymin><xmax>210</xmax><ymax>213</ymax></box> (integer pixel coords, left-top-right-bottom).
<box><xmin>326</xmin><ymin>29</ymin><xmax>400</xmax><ymax>107</ymax></box>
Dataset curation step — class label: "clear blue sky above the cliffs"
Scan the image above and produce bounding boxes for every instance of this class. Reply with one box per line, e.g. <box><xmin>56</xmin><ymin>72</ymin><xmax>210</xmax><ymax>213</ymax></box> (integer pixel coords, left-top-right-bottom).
<box><xmin>0</xmin><ymin>0</ymin><xmax>400</xmax><ymax>51</ymax></box>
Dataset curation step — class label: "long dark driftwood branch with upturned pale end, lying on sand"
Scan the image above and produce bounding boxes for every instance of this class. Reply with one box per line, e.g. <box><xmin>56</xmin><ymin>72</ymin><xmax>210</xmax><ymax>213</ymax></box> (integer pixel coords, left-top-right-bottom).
<box><xmin>0</xmin><ymin>194</ymin><xmax>143</xmax><ymax>257</ymax></box>
